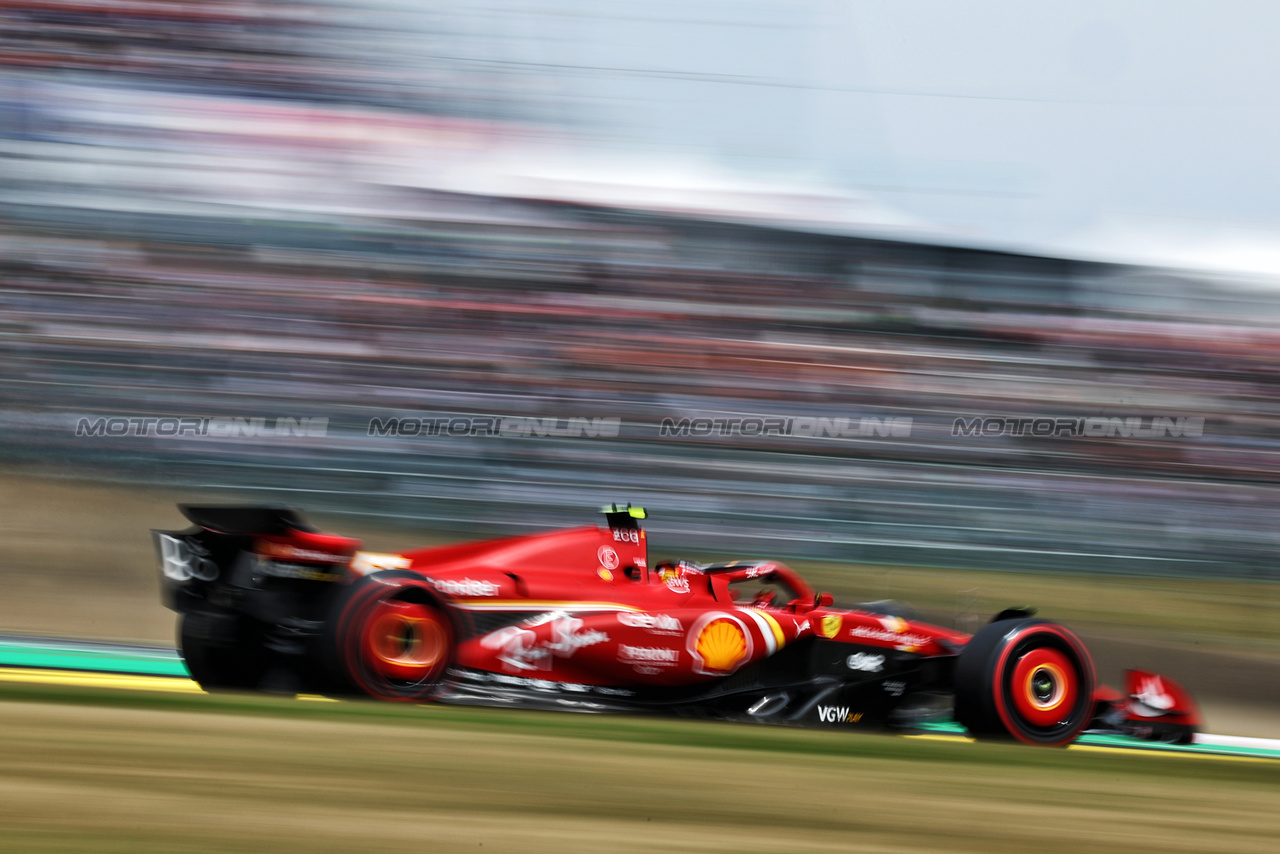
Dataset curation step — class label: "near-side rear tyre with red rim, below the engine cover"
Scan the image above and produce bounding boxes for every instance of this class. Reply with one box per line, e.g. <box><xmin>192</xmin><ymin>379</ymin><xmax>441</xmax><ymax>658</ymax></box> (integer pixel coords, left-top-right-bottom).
<box><xmin>325</xmin><ymin>570</ymin><xmax>457</xmax><ymax>702</ymax></box>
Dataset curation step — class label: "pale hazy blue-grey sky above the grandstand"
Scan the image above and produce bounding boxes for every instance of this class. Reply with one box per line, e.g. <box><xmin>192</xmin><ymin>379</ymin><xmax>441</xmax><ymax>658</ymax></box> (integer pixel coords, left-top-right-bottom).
<box><xmin>376</xmin><ymin>0</ymin><xmax>1280</xmax><ymax>273</ymax></box>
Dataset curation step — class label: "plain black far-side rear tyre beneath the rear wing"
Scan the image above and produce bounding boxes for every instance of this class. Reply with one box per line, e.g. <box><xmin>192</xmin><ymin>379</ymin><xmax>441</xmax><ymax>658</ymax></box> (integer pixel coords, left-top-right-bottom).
<box><xmin>178</xmin><ymin>611</ymin><xmax>265</xmax><ymax>691</ymax></box>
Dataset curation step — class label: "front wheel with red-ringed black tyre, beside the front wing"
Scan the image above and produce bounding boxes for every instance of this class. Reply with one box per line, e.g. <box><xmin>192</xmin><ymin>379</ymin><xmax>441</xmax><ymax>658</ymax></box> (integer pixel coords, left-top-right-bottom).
<box><xmin>955</xmin><ymin>617</ymin><xmax>1094</xmax><ymax>746</ymax></box>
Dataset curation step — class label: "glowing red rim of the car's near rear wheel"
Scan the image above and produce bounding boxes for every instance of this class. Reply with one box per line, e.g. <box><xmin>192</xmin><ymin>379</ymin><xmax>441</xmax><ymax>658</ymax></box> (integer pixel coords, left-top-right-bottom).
<box><xmin>360</xmin><ymin>599</ymin><xmax>449</xmax><ymax>682</ymax></box>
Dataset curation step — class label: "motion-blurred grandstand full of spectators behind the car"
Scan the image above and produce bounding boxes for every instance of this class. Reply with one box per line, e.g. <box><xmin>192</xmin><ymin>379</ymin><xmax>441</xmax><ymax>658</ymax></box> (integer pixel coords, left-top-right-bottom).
<box><xmin>0</xmin><ymin>0</ymin><xmax>1280</xmax><ymax>576</ymax></box>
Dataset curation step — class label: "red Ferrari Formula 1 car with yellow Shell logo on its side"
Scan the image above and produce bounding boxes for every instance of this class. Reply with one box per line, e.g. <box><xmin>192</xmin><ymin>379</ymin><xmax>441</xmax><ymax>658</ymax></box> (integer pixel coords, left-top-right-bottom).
<box><xmin>152</xmin><ymin>506</ymin><xmax>1201</xmax><ymax>745</ymax></box>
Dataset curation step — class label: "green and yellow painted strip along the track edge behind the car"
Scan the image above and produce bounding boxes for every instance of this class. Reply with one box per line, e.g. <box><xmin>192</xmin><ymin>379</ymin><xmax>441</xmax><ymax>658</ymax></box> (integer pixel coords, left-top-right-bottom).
<box><xmin>0</xmin><ymin>635</ymin><xmax>1280</xmax><ymax>761</ymax></box>
